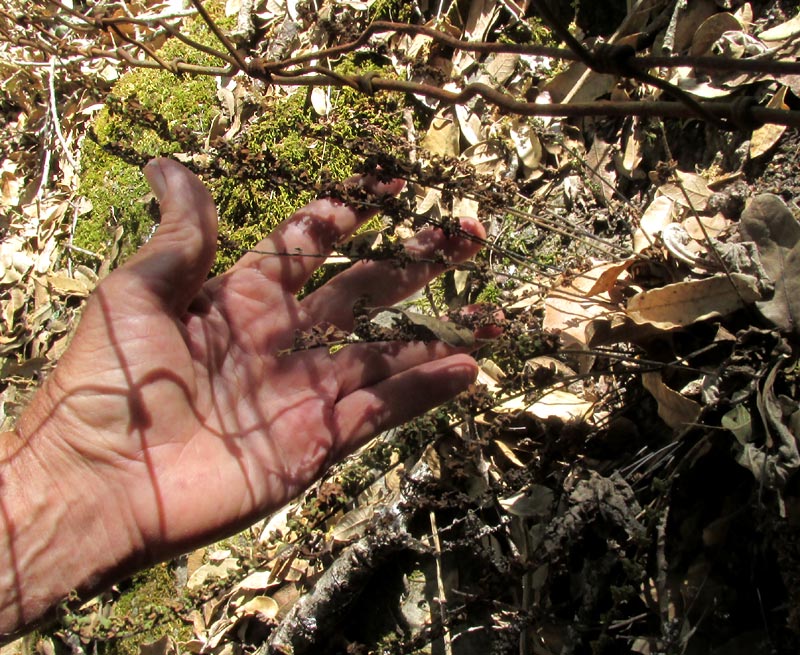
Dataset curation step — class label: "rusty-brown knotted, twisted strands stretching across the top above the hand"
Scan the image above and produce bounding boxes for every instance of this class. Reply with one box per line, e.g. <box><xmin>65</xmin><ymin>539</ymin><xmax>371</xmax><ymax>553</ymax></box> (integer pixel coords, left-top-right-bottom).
<box><xmin>10</xmin><ymin>8</ymin><xmax>800</xmax><ymax>129</ymax></box>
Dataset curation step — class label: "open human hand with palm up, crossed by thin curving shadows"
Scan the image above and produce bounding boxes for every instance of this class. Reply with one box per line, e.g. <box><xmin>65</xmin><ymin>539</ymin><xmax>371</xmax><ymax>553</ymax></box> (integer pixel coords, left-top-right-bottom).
<box><xmin>6</xmin><ymin>159</ymin><xmax>484</xmax><ymax>632</ymax></box>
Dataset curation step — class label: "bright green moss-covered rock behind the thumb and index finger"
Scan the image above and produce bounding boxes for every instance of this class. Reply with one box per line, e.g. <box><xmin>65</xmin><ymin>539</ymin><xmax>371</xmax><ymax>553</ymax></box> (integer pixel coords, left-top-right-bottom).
<box><xmin>74</xmin><ymin>19</ymin><xmax>402</xmax><ymax>271</ymax></box>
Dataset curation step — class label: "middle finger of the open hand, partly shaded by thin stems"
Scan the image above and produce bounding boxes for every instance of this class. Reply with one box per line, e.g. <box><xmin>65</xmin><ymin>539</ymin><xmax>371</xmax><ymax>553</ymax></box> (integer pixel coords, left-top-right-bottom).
<box><xmin>302</xmin><ymin>218</ymin><xmax>486</xmax><ymax>330</ymax></box>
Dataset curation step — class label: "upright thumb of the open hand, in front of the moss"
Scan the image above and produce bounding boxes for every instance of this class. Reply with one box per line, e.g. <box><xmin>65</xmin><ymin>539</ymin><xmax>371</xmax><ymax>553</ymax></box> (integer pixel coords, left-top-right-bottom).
<box><xmin>108</xmin><ymin>158</ymin><xmax>217</xmax><ymax>315</ymax></box>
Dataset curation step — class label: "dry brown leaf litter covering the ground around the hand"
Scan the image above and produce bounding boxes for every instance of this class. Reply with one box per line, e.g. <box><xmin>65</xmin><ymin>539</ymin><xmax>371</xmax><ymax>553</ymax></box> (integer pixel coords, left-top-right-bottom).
<box><xmin>0</xmin><ymin>0</ymin><xmax>800</xmax><ymax>655</ymax></box>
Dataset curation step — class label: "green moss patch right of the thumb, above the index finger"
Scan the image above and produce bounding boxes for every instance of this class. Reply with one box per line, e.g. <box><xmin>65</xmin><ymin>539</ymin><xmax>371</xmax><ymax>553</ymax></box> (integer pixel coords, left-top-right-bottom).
<box><xmin>211</xmin><ymin>61</ymin><xmax>402</xmax><ymax>270</ymax></box>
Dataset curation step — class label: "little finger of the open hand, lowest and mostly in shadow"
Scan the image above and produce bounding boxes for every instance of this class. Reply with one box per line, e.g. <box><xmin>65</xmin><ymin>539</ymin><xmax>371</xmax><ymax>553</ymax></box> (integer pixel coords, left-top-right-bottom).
<box><xmin>332</xmin><ymin>354</ymin><xmax>478</xmax><ymax>458</ymax></box>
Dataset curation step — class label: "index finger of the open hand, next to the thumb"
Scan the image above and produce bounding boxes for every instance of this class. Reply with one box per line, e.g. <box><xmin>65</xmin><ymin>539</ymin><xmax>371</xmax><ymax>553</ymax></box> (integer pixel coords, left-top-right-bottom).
<box><xmin>231</xmin><ymin>176</ymin><xmax>403</xmax><ymax>293</ymax></box>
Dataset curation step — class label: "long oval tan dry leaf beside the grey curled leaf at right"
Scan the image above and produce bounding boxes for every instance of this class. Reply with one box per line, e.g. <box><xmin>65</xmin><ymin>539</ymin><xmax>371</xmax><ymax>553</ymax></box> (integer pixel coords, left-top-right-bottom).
<box><xmin>626</xmin><ymin>273</ymin><xmax>761</xmax><ymax>330</ymax></box>
